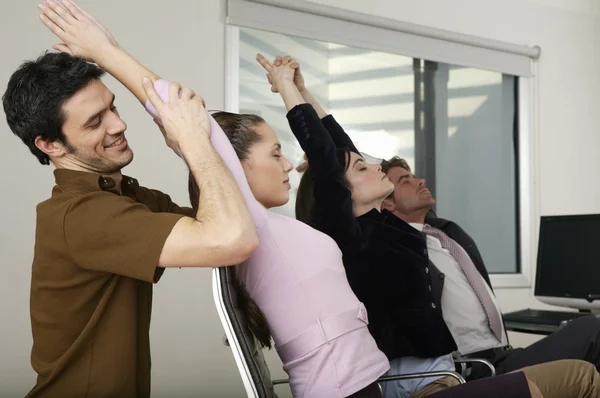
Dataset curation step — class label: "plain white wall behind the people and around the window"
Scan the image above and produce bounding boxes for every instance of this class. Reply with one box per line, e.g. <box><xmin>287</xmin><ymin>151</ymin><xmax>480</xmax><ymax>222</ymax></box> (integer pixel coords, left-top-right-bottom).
<box><xmin>0</xmin><ymin>0</ymin><xmax>600</xmax><ymax>398</ymax></box>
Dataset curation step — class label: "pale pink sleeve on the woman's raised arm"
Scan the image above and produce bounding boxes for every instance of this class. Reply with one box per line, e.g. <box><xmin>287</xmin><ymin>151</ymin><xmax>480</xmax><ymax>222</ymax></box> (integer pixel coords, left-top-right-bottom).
<box><xmin>146</xmin><ymin>79</ymin><xmax>268</xmax><ymax>228</ymax></box>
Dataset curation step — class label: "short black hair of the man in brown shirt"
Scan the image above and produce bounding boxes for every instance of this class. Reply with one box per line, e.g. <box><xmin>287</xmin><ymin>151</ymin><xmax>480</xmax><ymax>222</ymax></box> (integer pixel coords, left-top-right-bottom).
<box><xmin>2</xmin><ymin>52</ymin><xmax>105</xmax><ymax>164</ymax></box>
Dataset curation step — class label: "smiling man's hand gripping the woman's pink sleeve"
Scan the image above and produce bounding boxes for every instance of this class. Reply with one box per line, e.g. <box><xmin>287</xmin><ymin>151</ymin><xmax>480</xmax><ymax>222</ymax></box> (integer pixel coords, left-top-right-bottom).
<box><xmin>143</xmin><ymin>78</ymin><xmax>210</xmax><ymax>156</ymax></box>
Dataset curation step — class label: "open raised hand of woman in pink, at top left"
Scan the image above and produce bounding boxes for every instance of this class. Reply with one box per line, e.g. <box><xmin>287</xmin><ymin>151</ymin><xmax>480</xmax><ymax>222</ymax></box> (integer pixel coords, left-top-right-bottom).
<box><xmin>39</xmin><ymin>0</ymin><xmax>119</xmax><ymax>62</ymax></box>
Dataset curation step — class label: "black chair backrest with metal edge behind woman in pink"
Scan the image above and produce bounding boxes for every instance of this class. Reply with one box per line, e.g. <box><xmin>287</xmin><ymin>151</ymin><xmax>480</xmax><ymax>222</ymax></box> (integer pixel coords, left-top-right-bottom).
<box><xmin>212</xmin><ymin>266</ymin><xmax>277</xmax><ymax>398</ymax></box>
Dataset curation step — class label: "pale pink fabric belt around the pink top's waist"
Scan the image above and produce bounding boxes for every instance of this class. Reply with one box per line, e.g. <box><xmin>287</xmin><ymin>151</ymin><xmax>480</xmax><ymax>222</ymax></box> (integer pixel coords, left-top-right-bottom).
<box><xmin>275</xmin><ymin>303</ymin><xmax>369</xmax><ymax>364</ymax></box>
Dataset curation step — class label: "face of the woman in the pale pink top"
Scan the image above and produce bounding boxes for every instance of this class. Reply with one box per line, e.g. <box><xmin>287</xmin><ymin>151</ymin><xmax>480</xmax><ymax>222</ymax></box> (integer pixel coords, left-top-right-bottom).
<box><xmin>242</xmin><ymin>123</ymin><xmax>294</xmax><ymax>209</ymax></box>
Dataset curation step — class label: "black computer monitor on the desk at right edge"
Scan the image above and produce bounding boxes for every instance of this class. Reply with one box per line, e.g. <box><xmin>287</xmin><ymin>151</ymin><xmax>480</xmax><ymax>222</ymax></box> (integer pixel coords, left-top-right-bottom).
<box><xmin>535</xmin><ymin>214</ymin><xmax>600</xmax><ymax>309</ymax></box>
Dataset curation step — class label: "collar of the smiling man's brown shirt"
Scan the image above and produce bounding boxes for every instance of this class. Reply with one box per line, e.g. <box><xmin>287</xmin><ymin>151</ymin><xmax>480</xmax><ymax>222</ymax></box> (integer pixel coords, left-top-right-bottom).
<box><xmin>54</xmin><ymin>169</ymin><xmax>139</xmax><ymax>193</ymax></box>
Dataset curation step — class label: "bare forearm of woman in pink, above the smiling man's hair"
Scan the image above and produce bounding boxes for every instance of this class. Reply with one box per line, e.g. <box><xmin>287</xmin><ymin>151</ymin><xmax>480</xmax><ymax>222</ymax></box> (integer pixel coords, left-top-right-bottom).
<box><xmin>93</xmin><ymin>46</ymin><xmax>160</xmax><ymax>104</ymax></box>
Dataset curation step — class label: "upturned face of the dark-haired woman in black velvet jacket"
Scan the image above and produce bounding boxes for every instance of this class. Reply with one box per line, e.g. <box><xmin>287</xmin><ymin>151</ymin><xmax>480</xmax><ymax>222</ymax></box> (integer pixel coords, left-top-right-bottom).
<box><xmin>345</xmin><ymin>152</ymin><xmax>394</xmax><ymax>210</ymax></box>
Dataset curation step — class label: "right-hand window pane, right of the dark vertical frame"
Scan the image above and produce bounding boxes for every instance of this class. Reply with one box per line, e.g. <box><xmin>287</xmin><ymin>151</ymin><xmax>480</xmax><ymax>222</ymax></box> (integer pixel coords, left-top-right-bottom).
<box><xmin>435</xmin><ymin>64</ymin><xmax>517</xmax><ymax>273</ymax></box>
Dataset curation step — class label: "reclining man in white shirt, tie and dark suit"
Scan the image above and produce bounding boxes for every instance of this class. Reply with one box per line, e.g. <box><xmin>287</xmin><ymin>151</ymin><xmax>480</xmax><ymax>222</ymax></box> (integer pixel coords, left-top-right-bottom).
<box><xmin>382</xmin><ymin>157</ymin><xmax>600</xmax><ymax>374</ymax></box>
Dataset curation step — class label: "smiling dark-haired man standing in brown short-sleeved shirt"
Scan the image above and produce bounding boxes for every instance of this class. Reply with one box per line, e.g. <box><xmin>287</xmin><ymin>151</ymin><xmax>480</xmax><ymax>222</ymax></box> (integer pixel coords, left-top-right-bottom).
<box><xmin>3</xmin><ymin>49</ymin><xmax>258</xmax><ymax>398</ymax></box>
